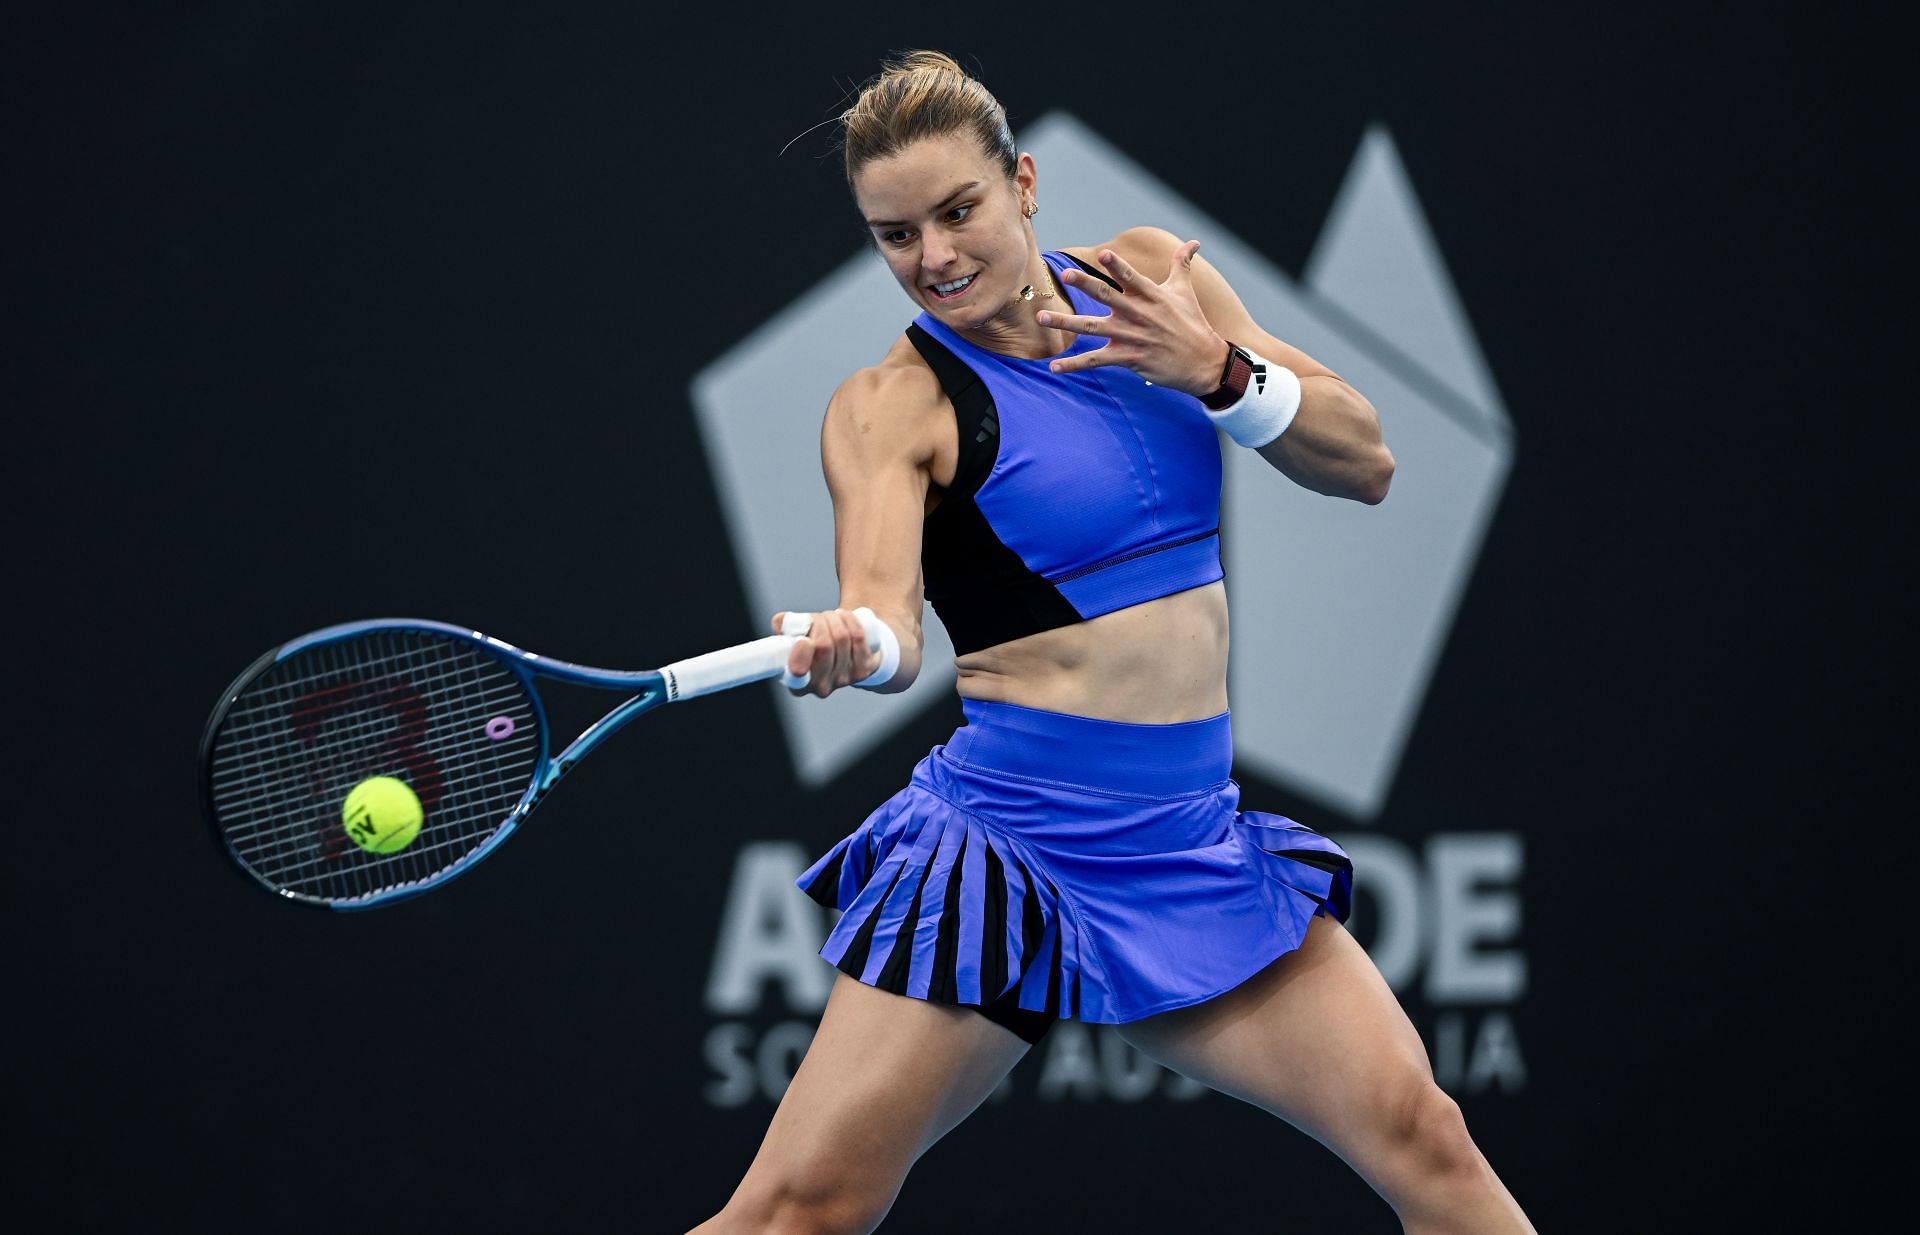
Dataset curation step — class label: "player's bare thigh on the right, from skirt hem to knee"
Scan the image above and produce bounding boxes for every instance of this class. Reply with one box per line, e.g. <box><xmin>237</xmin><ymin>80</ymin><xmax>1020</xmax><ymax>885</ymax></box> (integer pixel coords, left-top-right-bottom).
<box><xmin>1119</xmin><ymin>916</ymin><xmax>1432</xmax><ymax>1174</ymax></box>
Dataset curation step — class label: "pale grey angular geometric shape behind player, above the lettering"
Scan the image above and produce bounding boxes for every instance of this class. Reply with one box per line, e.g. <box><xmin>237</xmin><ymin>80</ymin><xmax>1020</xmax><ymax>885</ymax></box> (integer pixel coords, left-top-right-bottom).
<box><xmin>693</xmin><ymin>111</ymin><xmax>1513</xmax><ymax>822</ymax></box>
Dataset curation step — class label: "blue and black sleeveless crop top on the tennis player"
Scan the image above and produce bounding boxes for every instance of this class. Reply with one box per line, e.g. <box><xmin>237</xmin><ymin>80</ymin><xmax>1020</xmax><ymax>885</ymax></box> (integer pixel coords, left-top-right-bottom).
<box><xmin>906</xmin><ymin>254</ymin><xmax>1221</xmax><ymax>655</ymax></box>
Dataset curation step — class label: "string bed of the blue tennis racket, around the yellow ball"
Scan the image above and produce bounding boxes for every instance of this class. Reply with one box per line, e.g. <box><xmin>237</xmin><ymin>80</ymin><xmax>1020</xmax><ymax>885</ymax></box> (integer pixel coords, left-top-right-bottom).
<box><xmin>207</xmin><ymin>630</ymin><xmax>541</xmax><ymax>901</ymax></box>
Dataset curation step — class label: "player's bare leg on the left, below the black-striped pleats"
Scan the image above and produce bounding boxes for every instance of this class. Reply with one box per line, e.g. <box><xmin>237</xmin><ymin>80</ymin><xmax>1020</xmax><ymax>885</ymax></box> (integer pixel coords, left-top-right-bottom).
<box><xmin>693</xmin><ymin>974</ymin><xmax>1027</xmax><ymax>1235</ymax></box>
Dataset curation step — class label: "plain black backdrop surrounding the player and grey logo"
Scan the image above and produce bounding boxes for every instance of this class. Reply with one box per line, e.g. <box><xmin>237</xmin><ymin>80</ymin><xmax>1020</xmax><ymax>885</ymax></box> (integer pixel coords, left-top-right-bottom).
<box><xmin>4</xmin><ymin>4</ymin><xmax>1910</xmax><ymax>1231</ymax></box>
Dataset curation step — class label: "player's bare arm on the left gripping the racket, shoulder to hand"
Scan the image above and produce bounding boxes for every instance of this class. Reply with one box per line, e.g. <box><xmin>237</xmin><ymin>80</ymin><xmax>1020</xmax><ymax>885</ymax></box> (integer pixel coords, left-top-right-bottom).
<box><xmin>774</xmin><ymin>363</ymin><xmax>952</xmax><ymax>699</ymax></box>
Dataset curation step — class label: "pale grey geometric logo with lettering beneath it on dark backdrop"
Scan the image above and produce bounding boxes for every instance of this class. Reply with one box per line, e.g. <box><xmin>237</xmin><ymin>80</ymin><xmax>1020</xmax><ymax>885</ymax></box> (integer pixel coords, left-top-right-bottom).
<box><xmin>693</xmin><ymin>113</ymin><xmax>1526</xmax><ymax>1106</ymax></box>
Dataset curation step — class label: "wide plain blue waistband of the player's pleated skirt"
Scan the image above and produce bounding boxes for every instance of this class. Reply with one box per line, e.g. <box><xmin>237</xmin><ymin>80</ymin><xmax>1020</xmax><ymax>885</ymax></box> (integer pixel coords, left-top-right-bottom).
<box><xmin>947</xmin><ymin>699</ymin><xmax>1233</xmax><ymax>795</ymax></box>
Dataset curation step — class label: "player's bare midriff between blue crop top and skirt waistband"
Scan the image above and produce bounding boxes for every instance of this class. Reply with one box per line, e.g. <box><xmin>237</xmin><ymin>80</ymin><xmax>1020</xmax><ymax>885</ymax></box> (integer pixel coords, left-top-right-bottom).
<box><xmin>954</xmin><ymin>580</ymin><xmax>1227</xmax><ymax>724</ymax></box>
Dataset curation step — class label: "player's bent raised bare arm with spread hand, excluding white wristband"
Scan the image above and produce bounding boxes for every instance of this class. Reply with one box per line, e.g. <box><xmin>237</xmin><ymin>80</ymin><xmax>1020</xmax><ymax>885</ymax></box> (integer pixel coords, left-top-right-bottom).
<box><xmin>1050</xmin><ymin>227</ymin><xmax>1394</xmax><ymax>505</ymax></box>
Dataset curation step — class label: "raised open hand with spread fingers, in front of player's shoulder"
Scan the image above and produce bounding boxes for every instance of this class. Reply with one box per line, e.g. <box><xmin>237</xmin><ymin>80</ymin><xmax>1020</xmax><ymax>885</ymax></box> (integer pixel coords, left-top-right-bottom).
<box><xmin>1037</xmin><ymin>240</ymin><xmax>1227</xmax><ymax>396</ymax></box>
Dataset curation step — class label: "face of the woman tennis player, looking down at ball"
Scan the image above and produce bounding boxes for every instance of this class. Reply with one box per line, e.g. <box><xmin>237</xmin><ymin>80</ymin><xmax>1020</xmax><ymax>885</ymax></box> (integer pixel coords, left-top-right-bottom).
<box><xmin>854</xmin><ymin>133</ymin><xmax>1037</xmax><ymax>330</ymax></box>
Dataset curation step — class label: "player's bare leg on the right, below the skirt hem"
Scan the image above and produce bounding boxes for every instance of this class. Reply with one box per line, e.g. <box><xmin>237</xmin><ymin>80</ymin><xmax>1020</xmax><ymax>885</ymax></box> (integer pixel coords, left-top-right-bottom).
<box><xmin>1119</xmin><ymin>916</ymin><xmax>1532</xmax><ymax>1233</ymax></box>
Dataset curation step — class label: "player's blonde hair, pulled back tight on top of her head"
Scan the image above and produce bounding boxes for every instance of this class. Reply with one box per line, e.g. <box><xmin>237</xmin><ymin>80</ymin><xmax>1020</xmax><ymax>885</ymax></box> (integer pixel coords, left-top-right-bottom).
<box><xmin>839</xmin><ymin>52</ymin><xmax>1020</xmax><ymax>188</ymax></box>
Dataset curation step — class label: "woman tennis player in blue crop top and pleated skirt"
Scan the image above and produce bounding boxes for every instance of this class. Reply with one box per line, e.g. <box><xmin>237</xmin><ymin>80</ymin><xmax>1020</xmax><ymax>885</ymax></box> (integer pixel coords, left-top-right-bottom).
<box><xmin>697</xmin><ymin>52</ymin><xmax>1532</xmax><ymax>1235</ymax></box>
